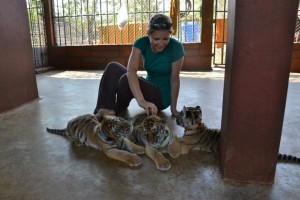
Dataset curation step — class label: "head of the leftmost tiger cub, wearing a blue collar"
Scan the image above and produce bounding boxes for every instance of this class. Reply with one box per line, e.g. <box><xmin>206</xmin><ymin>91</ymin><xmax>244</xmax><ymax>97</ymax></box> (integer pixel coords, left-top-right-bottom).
<box><xmin>101</xmin><ymin>116</ymin><xmax>133</xmax><ymax>141</ymax></box>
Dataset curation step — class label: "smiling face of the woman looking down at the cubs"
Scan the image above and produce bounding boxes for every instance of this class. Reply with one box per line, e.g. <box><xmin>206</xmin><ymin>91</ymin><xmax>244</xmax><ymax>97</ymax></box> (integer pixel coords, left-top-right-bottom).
<box><xmin>149</xmin><ymin>30</ymin><xmax>171</xmax><ymax>53</ymax></box>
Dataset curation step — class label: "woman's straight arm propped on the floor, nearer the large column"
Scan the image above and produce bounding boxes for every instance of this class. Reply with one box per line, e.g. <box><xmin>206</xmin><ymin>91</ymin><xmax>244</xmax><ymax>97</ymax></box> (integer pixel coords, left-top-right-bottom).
<box><xmin>170</xmin><ymin>57</ymin><xmax>184</xmax><ymax>116</ymax></box>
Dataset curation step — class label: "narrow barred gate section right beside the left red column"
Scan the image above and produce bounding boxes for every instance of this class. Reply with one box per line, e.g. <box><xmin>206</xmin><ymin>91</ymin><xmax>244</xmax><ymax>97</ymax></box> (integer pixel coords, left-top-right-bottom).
<box><xmin>26</xmin><ymin>0</ymin><xmax>48</xmax><ymax>68</ymax></box>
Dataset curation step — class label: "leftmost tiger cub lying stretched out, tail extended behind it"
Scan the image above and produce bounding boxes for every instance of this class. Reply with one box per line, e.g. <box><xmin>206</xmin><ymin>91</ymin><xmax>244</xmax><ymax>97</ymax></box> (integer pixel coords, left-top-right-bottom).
<box><xmin>46</xmin><ymin>110</ymin><xmax>145</xmax><ymax>166</ymax></box>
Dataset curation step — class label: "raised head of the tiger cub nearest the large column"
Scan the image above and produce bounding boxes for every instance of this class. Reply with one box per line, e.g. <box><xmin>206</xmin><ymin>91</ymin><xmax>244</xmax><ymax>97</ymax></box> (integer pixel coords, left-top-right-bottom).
<box><xmin>176</xmin><ymin>106</ymin><xmax>202</xmax><ymax>130</ymax></box>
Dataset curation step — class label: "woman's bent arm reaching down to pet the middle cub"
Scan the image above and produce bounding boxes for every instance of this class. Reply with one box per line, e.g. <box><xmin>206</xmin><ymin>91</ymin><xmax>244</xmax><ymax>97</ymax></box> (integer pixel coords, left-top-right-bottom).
<box><xmin>127</xmin><ymin>47</ymin><xmax>157</xmax><ymax>115</ymax></box>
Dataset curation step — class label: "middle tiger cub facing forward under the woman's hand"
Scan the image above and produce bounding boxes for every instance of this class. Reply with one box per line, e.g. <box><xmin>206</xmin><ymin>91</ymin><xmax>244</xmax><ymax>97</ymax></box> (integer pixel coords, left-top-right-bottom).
<box><xmin>132</xmin><ymin>114</ymin><xmax>180</xmax><ymax>170</ymax></box>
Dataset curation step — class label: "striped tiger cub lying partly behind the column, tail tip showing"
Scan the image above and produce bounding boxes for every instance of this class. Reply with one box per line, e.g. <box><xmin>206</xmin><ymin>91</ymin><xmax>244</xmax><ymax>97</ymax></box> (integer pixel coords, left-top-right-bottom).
<box><xmin>176</xmin><ymin>106</ymin><xmax>300</xmax><ymax>163</ymax></box>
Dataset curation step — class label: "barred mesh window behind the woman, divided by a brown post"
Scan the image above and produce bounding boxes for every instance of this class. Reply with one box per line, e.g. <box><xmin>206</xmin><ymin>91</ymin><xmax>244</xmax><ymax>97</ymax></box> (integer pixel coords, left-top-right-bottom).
<box><xmin>53</xmin><ymin>0</ymin><xmax>202</xmax><ymax>46</ymax></box>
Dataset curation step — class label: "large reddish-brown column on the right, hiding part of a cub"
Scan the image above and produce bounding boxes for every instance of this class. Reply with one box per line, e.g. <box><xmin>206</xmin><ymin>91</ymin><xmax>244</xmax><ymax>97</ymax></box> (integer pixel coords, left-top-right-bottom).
<box><xmin>220</xmin><ymin>0</ymin><xmax>299</xmax><ymax>183</ymax></box>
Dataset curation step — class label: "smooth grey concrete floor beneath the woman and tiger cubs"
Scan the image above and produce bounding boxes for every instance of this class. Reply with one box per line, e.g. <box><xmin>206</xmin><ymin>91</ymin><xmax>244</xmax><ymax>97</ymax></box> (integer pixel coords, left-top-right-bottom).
<box><xmin>0</xmin><ymin>69</ymin><xmax>300</xmax><ymax>200</ymax></box>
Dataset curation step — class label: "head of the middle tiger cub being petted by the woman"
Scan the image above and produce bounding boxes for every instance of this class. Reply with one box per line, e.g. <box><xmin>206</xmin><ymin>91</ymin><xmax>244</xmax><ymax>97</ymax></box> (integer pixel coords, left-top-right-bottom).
<box><xmin>142</xmin><ymin>115</ymin><xmax>171</xmax><ymax>146</ymax></box>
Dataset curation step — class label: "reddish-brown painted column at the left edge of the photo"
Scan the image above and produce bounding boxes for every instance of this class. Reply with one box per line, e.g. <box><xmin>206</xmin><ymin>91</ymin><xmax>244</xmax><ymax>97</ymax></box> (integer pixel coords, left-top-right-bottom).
<box><xmin>0</xmin><ymin>0</ymin><xmax>38</xmax><ymax>113</ymax></box>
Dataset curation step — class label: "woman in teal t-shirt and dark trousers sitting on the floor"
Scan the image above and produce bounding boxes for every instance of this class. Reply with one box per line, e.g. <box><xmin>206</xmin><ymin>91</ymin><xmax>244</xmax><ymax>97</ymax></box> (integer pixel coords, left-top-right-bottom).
<box><xmin>94</xmin><ymin>14</ymin><xmax>185</xmax><ymax>116</ymax></box>
